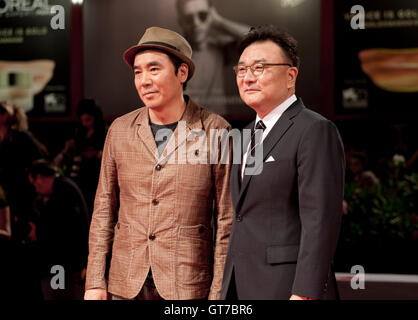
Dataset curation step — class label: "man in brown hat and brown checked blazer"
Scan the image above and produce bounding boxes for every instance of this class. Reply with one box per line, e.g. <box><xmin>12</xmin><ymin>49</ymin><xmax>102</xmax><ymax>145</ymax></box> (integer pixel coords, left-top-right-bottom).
<box><xmin>85</xmin><ymin>27</ymin><xmax>232</xmax><ymax>300</ymax></box>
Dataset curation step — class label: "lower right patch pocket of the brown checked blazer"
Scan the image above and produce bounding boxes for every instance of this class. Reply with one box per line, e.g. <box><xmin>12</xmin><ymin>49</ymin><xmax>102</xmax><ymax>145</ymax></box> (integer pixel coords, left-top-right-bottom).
<box><xmin>176</xmin><ymin>224</ymin><xmax>213</xmax><ymax>286</ymax></box>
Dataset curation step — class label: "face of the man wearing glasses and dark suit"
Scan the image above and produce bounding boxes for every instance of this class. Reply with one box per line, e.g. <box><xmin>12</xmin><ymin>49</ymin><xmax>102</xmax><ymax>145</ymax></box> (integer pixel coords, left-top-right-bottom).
<box><xmin>236</xmin><ymin>40</ymin><xmax>298</xmax><ymax>118</ymax></box>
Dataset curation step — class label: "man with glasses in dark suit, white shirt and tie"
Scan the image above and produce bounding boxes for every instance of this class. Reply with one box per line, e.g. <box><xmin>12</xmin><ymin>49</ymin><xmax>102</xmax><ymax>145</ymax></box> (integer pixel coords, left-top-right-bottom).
<box><xmin>221</xmin><ymin>26</ymin><xmax>345</xmax><ymax>299</ymax></box>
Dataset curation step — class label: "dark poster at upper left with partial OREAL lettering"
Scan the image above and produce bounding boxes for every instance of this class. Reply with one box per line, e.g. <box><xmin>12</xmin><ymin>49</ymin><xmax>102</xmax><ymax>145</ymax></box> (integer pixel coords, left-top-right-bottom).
<box><xmin>0</xmin><ymin>0</ymin><xmax>71</xmax><ymax>116</ymax></box>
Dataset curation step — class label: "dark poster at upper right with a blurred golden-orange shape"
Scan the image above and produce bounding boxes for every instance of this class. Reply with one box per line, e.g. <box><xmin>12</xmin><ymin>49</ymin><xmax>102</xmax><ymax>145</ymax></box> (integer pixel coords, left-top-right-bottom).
<box><xmin>334</xmin><ymin>0</ymin><xmax>418</xmax><ymax>114</ymax></box>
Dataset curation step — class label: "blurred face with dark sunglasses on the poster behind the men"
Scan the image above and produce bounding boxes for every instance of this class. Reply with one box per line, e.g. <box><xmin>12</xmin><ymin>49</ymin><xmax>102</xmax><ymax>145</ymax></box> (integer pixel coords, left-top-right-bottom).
<box><xmin>177</xmin><ymin>0</ymin><xmax>212</xmax><ymax>45</ymax></box>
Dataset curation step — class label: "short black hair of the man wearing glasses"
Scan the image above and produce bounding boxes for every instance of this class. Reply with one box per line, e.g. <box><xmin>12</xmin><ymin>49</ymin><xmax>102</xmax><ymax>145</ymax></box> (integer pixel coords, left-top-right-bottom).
<box><xmin>238</xmin><ymin>25</ymin><xmax>300</xmax><ymax>68</ymax></box>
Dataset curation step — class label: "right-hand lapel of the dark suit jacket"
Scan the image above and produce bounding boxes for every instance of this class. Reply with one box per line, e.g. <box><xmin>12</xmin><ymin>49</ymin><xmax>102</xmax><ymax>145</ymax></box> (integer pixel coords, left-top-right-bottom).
<box><xmin>236</xmin><ymin>98</ymin><xmax>305</xmax><ymax>210</ymax></box>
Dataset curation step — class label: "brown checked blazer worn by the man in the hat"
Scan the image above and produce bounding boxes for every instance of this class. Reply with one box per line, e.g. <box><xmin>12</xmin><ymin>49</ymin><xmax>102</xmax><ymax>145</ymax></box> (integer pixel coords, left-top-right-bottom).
<box><xmin>86</xmin><ymin>96</ymin><xmax>233</xmax><ymax>300</ymax></box>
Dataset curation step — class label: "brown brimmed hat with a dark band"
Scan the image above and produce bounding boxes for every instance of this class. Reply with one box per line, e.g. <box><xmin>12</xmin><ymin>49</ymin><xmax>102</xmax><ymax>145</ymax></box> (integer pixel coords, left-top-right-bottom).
<box><xmin>123</xmin><ymin>27</ymin><xmax>195</xmax><ymax>79</ymax></box>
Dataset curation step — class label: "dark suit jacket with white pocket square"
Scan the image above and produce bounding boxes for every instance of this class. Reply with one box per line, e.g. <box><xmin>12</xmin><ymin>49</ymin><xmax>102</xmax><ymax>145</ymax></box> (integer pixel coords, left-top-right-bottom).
<box><xmin>221</xmin><ymin>99</ymin><xmax>345</xmax><ymax>299</ymax></box>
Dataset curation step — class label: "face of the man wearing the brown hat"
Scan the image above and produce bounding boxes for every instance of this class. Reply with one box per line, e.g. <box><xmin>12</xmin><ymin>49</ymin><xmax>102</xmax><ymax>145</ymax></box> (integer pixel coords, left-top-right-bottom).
<box><xmin>134</xmin><ymin>50</ymin><xmax>188</xmax><ymax>109</ymax></box>
